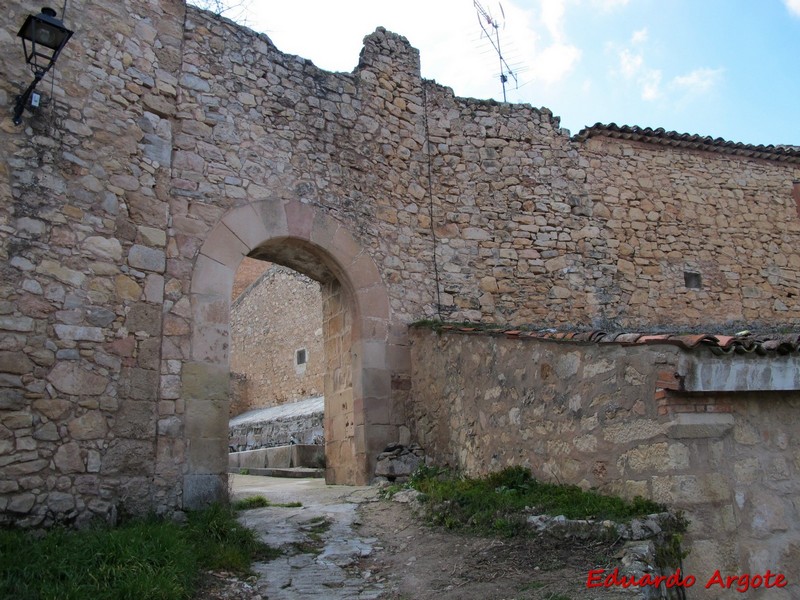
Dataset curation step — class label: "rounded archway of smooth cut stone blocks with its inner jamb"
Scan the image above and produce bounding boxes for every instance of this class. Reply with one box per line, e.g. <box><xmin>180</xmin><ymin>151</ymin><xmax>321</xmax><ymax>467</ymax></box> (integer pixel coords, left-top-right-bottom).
<box><xmin>182</xmin><ymin>200</ymin><xmax>396</xmax><ymax>508</ymax></box>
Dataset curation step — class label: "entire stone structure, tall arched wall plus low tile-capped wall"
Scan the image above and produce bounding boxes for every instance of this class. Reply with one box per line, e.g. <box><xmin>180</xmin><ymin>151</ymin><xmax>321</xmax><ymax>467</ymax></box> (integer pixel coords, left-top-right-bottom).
<box><xmin>0</xmin><ymin>0</ymin><xmax>800</xmax><ymax>598</ymax></box>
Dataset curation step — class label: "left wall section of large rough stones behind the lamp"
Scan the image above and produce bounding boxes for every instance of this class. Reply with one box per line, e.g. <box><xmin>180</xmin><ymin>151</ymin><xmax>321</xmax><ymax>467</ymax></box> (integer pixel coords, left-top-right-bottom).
<box><xmin>0</xmin><ymin>0</ymin><xmax>184</xmax><ymax>526</ymax></box>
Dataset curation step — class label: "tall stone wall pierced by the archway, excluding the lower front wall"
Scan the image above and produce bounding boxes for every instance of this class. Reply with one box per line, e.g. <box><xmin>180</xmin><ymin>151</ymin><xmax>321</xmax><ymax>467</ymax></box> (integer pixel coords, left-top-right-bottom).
<box><xmin>0</xmin><ymin>0</ymin><xmax>800</xmax><ymax>525</ymax></box>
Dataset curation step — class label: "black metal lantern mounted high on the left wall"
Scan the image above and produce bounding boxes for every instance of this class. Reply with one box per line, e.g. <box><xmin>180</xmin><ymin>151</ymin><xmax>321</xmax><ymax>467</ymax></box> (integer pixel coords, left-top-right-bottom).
<box><xmin>14</xmin><ymin>8</ymin><xmax>73</xmax><ymax>125</ymax></box>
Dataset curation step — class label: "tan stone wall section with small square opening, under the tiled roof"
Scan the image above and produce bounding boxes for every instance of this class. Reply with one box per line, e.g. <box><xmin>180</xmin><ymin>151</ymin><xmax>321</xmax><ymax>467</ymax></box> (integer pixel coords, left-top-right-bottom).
<box><xmin>580</xmin><ymin>138</ymin><xmax>800</xmax><ymax>331</ymax></box>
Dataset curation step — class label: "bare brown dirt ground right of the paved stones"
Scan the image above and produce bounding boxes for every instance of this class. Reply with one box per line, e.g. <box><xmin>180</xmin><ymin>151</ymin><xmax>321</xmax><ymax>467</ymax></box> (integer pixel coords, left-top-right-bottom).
<box><xmin>357</xmin><ymin>494</ymin><xmax>635</xmax><ymax>600</ymax></box>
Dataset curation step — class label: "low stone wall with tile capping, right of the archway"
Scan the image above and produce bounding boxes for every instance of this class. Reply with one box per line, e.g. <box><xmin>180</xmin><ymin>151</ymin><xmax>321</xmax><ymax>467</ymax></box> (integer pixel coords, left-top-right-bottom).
<box><xmin>408</xmin><ymin>329</ymin><xmax>800</xmax><ymax>598</ymax></box>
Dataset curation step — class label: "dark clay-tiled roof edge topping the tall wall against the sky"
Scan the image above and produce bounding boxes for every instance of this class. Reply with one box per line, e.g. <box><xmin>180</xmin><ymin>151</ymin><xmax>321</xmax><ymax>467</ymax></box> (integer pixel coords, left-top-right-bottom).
<box><xmin>573</xmin><ymin>123</ymin><xmax>800</xmax><ymax>164</ymax></box>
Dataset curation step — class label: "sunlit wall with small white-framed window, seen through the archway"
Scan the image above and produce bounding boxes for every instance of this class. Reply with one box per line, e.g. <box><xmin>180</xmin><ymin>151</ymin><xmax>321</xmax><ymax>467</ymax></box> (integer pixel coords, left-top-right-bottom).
<box><xmin>230</xmin><ymin>261</ymin><xmax>325</xmax><ymax>416</ymax></box>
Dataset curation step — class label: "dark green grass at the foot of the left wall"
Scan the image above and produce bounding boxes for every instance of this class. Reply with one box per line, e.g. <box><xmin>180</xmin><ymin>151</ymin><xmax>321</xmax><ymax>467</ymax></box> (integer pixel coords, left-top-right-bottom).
<box><xmin>0</xmin><ymin>505</ymin><xmax>278</xmax><ymax>600</ymax></box>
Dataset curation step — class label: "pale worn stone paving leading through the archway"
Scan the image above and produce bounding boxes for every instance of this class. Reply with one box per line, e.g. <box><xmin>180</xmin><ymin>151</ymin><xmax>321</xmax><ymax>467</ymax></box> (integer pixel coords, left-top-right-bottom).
<box><xmin>231</xmin><ymin>475</ymin><xmax>383</xmax><ymax>600</ymax></box>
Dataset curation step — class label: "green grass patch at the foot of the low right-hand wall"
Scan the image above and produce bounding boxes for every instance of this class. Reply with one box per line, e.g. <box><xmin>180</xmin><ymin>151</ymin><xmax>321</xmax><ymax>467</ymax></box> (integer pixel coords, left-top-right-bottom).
<box><xmin>409</xmin><ymin>467</ymin><xmax>666</xmax><ymax>536</ymax></box>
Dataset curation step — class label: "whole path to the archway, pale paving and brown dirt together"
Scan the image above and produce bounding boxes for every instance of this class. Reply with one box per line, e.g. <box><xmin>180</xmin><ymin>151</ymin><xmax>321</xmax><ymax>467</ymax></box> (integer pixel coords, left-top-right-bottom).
<box><xmin>205</xmin><ymin>475</ymin><xmax>636</xmax><ymax>600</ymax></box>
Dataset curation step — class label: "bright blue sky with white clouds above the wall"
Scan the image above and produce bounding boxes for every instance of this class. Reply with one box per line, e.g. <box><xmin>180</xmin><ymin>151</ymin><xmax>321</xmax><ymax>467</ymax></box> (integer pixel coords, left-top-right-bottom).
<box><xmin>211</xmin><ymin>0</ymin><xmax>800</xmax><ymax>145</ymax></box>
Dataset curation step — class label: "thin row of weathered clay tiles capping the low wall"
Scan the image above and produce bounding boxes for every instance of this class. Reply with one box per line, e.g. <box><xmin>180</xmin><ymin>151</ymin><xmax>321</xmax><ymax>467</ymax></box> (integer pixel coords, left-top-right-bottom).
<box><xmin>434</xmin><ymin>325</ymin><xmax>800</xmax><ymax>355</ymax></box>
